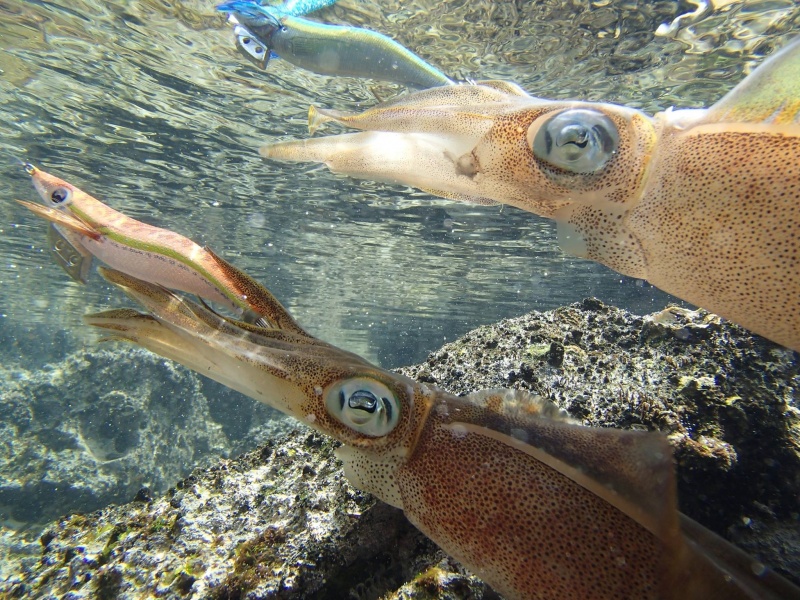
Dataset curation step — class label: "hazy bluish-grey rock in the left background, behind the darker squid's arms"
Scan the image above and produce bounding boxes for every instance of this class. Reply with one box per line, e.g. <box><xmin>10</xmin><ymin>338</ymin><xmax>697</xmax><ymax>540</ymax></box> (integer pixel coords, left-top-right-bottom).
<box><xmin>0</xmin><ymin>347</ymin><xmax>288</xmax><ymax>528</ymax></box>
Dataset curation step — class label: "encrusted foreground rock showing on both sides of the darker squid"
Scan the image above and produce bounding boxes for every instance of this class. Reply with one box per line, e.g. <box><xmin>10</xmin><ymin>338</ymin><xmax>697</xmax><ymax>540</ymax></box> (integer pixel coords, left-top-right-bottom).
<box><xmin>0</xmin><ymin>299</ymin><xmax>800</xmax><ymax>600</ymax></box>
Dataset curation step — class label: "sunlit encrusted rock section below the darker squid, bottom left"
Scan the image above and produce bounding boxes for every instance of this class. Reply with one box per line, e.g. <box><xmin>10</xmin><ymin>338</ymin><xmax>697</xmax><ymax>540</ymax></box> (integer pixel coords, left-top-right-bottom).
<box><xmin>0</xmin><ymin>429</ymin><xmax>490</xmax><ymax>599</ymax></box>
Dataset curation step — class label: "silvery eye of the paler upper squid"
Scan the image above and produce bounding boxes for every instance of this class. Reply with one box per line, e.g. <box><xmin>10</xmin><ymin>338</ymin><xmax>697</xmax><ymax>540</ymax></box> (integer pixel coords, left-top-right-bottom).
<box><xmin>532</xmin><ymin>108</ymin><xmax>619</xmax><ymax>173</ymax></box>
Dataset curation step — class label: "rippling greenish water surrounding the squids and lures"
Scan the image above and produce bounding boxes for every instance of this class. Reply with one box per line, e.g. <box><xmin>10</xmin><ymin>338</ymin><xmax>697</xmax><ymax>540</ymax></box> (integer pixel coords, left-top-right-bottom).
<box><xmin>0</xmin><ymin>0</ymin><xmax>800</xmax><ymax>366</ymax></box>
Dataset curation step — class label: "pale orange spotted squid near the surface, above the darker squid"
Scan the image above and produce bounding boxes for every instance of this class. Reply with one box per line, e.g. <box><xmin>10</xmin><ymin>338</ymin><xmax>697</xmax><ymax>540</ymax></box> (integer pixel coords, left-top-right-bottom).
<box><xmin>261</xmin><ymin>40</ymin><xmax>800</xmax><ymax>350</ymax></box>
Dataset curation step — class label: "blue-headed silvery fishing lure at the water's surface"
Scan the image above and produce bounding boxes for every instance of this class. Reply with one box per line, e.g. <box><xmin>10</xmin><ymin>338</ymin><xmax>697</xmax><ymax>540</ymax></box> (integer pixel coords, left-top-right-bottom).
<box><xmin>217</xmin><ymin>0</ymin><xmax>453</xmax><ymax>88</ymax></box>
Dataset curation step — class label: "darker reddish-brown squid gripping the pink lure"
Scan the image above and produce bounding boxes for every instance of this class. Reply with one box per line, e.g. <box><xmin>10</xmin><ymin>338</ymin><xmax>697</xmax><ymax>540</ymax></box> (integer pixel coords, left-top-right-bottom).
<box><xmin>54</xmin><ymin>249</ymin><xmax>800</xmax><ymax>600</ymax></box>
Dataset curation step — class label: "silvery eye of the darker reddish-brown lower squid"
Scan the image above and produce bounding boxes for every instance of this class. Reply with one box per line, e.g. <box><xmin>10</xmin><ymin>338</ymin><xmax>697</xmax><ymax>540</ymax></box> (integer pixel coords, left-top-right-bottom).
<box><xmin>325</xmin><ymin>377</ymin><xmax>400</xmax><ymax>437</ymax></box>
